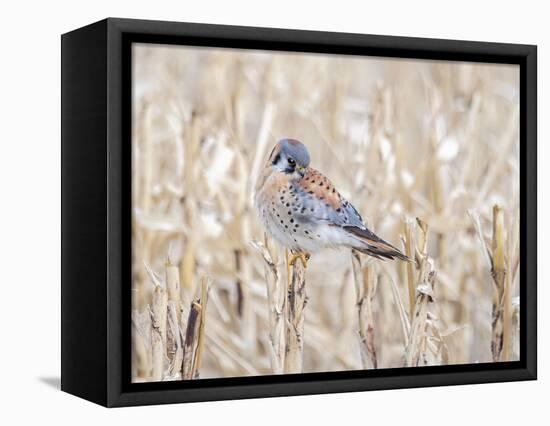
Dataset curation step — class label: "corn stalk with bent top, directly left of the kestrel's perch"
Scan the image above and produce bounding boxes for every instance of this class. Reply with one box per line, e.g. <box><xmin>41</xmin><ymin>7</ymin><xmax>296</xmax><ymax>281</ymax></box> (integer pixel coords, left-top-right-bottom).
<box><xmin>252</xmin><ymin>238</ymin><xmax>286</xmax><ymax>374</ymax></box>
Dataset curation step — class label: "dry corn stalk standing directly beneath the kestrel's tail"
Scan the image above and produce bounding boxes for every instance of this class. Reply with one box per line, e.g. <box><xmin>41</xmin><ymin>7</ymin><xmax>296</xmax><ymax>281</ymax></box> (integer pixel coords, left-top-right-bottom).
<box><xmin>351</xmin><ymin>250</ymin><xmax>378</xmax><ymax>369</ymax></box>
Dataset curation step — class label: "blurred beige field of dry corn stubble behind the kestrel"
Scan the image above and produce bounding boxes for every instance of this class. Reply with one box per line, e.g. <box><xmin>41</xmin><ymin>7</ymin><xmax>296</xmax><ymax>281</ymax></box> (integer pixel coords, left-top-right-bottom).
<box><xmin>132</xmin><ymin>45</ymin><xmax>520</xmax><ymax>381</ymax></box>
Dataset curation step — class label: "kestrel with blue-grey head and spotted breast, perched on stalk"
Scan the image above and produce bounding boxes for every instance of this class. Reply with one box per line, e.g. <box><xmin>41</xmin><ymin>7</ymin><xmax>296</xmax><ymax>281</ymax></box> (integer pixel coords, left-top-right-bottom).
<box><xmin>254</xmin><ymin>139</ymin><xmax>409</xmax><ymax>265</ymax></box>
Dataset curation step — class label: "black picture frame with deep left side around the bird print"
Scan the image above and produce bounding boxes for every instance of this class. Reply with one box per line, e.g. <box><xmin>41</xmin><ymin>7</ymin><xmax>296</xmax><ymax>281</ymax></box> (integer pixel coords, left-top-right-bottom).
<box><xmin>61</xmin><ymin>18</ymin><xmax>537</xmax><ymax>407</ymax></box>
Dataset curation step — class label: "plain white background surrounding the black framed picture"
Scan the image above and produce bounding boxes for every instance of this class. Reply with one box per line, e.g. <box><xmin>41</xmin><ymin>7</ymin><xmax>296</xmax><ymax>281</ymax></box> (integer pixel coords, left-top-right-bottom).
<box><xmin>0</xmin><ymin>0</ymin><xmax>550</xmax><ymax>426</ymax></box>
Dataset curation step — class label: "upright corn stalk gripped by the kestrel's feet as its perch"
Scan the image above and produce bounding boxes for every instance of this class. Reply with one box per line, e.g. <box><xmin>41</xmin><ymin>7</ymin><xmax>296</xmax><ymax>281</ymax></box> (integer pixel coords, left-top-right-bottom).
<box><xmin>284</xmin><ymin>251</ymin><xmax>307</xmax><ymax>373</ymax></box>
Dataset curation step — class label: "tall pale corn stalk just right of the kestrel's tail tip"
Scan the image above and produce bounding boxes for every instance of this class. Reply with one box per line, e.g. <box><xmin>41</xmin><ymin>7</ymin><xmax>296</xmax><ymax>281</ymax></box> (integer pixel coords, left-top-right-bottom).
<box><xmin>404</xmin><ymin>218</ymin><xmax>435</xmax><ymax>367</ymax></box>
